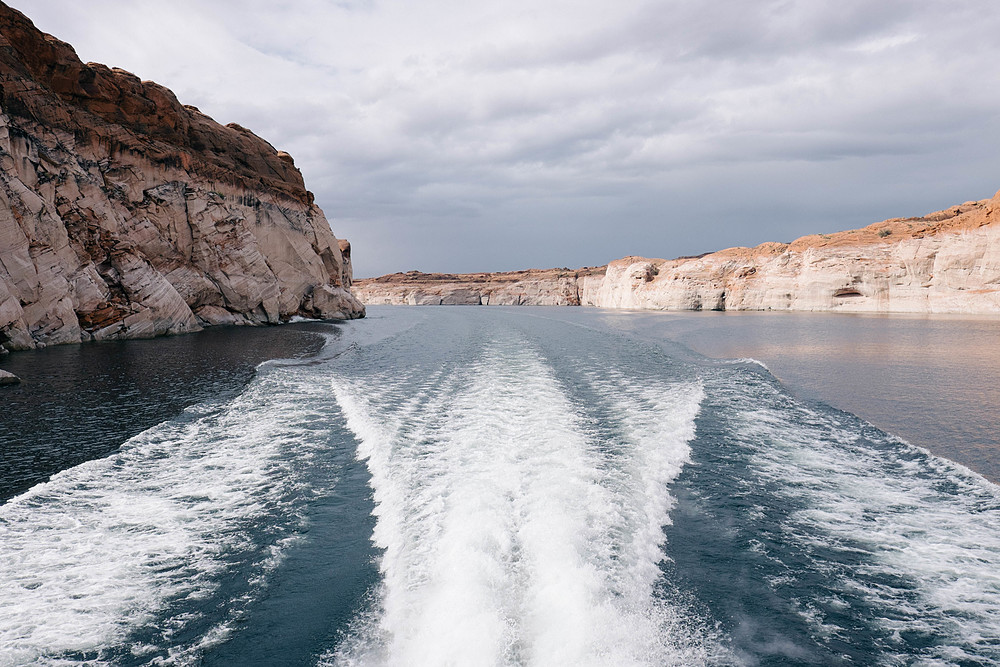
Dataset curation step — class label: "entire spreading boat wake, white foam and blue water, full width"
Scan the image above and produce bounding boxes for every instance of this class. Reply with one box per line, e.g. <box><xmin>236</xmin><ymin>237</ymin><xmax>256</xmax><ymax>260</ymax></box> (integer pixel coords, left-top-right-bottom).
<box><xmin>0</xmin><ymin>308</ymin><xmax>1000</xmax><ymax>665</ymax></box>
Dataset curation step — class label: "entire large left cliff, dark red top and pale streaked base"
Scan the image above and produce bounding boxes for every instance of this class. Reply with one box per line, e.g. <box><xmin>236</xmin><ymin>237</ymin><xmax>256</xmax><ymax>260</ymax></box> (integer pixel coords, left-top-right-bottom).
<box><xmin>0</xmin><ymin>3</ymin><xmax>364</xmax><ymax>349</ymax></box>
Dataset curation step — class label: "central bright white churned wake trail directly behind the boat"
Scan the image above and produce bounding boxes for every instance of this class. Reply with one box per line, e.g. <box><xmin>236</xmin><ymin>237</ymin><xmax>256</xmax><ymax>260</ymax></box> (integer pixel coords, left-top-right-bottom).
<box><xmin>327</xmin><ymin>332</ymin><xmax>711</xmax><ymax>665</ymax></box>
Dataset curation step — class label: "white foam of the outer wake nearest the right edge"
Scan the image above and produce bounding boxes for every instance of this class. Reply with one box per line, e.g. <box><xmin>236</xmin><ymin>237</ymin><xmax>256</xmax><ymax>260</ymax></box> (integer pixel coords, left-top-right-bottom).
<box><xmin>741</xmin><ymin>384</ymin><xmax>1000</xmax><ymax>664</ymax></box>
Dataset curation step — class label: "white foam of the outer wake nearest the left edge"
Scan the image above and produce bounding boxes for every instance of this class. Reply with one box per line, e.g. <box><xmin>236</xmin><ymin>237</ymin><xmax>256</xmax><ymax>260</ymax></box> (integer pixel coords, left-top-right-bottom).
<box><xmin>0</xmin><ymin>372</ymin><xmax>336</xmax><ymax>667</ymax></box>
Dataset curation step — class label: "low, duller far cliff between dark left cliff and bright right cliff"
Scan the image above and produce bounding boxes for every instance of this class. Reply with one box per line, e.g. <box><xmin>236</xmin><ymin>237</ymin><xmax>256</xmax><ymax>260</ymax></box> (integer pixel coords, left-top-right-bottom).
<box><xmin>354</xmin><ymin>267</ymin><xmax>604</xmax><ymax>306</ymax></box>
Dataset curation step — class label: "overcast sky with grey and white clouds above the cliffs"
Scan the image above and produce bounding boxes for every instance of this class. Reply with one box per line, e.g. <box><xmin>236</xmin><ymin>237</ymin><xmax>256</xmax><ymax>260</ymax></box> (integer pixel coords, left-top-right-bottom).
<box><xmin>9</xmin><ymin>0</ymin><xmax>1000</xmax><ymax>277</ymax></box>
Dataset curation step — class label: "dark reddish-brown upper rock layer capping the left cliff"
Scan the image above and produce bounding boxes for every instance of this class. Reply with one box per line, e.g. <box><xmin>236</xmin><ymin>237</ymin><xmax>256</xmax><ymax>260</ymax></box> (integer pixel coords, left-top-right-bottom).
<box><xmin>0</xmin><ymin>3</ymin><xmax>312</xmax><ymax>204</ymax></box>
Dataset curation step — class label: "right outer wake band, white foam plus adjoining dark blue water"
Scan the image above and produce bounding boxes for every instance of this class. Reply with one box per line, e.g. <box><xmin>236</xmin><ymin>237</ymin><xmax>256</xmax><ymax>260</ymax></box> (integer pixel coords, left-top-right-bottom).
<box><xmin>667</xmin><ymin>364</ymin><xmax>1000</xmax><ymax>667</ymax></box>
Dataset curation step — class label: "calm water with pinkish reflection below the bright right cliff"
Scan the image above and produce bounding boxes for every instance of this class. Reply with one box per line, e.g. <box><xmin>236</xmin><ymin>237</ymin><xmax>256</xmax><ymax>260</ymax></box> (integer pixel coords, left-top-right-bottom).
<box><xmin>584</xmin><ymin>313</ymin><xmax>1000</xmax><ymax>482</ymax></box>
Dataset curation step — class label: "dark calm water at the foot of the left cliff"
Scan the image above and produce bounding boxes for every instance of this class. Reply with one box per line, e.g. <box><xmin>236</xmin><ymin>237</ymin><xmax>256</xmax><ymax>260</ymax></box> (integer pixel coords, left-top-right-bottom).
<box><xmin>0</xmin><ymin>324</ymin><xmax>324</xmax><ymax>502</ymax></box>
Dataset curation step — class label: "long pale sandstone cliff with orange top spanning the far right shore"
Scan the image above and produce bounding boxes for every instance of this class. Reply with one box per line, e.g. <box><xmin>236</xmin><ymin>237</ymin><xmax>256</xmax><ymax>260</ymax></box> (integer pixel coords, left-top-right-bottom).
<box><xmin>360</xmin><ymin>188</ymin><xmax>1000</xmax><ymax>314</ymax></box>
